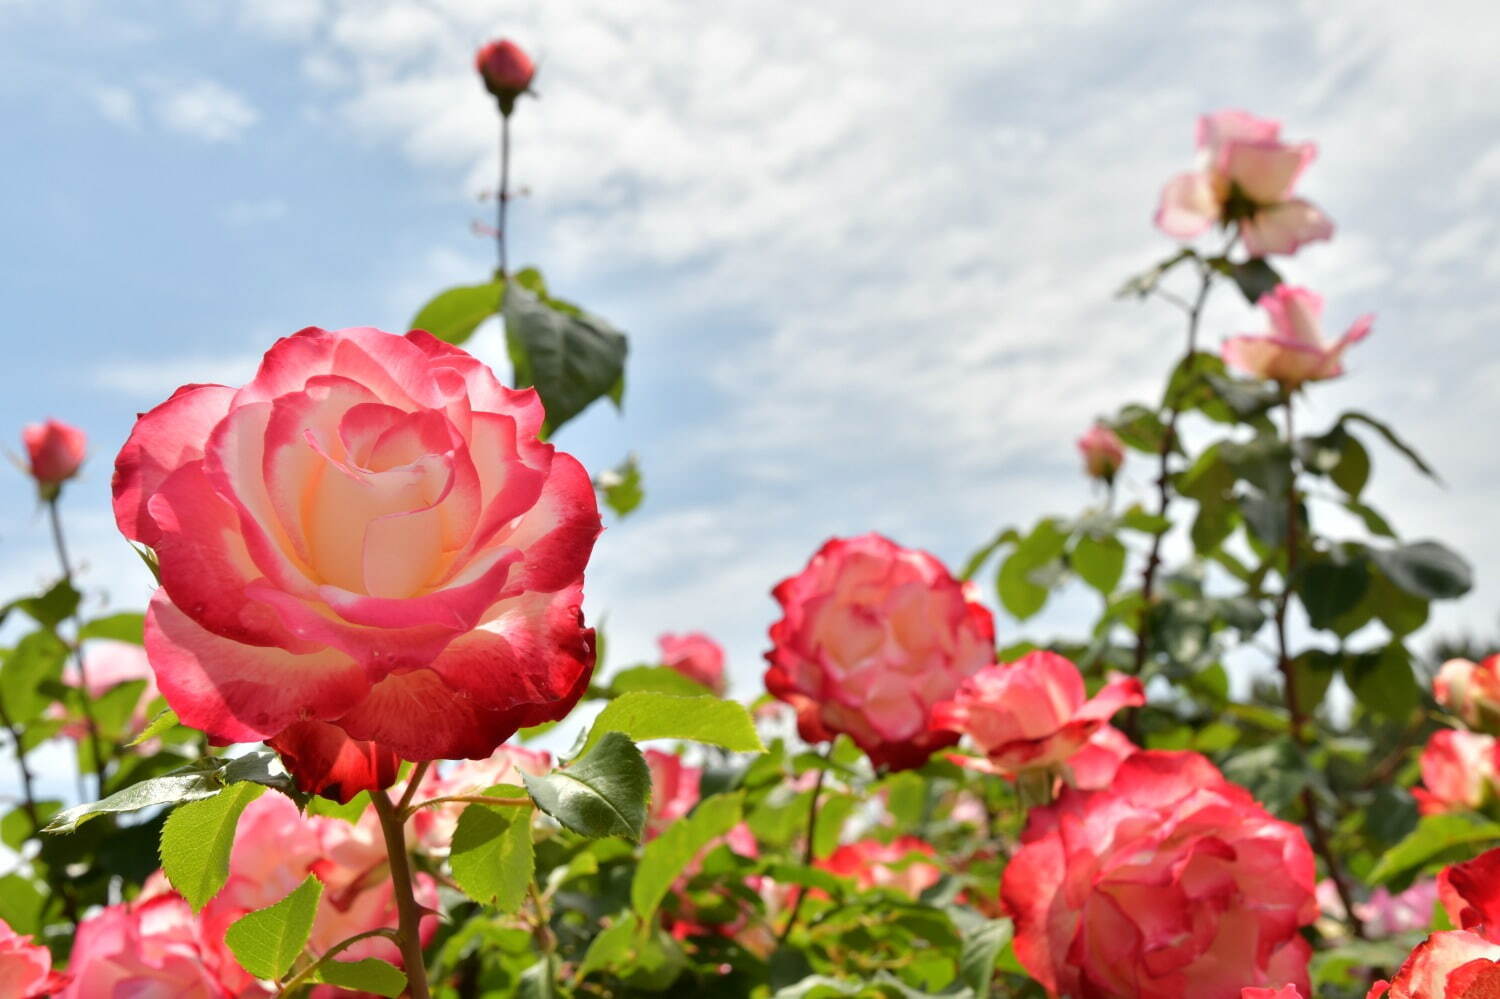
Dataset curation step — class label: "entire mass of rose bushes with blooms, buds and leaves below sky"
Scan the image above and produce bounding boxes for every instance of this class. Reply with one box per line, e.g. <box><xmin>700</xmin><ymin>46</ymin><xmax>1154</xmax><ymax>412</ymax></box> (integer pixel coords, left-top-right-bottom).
<box><xmin>0</xmin><ymin>35</ymin><xmax>1500</xmax><ymax>999</ymax></box>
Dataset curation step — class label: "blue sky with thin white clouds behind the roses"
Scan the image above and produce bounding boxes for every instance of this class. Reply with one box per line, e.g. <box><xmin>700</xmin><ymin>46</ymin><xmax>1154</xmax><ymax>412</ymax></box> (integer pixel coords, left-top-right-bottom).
<box><xmin>0</xmin><ymin>0</ymin><xmax>1500</xmax><ymax>729</ymax></box>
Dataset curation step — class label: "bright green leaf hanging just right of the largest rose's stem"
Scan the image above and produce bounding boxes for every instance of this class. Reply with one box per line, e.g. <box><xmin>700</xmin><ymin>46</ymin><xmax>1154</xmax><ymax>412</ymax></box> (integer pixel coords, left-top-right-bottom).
<box><xmin>449</xmin><ymin>788</ymin><xmax>536</xmax><ymax>912</ymax></box>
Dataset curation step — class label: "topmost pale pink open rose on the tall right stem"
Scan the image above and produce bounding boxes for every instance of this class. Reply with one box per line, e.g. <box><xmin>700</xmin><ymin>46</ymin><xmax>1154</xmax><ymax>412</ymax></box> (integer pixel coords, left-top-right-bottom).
<box><xmin>1157</xmin><ymin>111</ymin><xmax>1334</xmax><ymax>257</ymax></box>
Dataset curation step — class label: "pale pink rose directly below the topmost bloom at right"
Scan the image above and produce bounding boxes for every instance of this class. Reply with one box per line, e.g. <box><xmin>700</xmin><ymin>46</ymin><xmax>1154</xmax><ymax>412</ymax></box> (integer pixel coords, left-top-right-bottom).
<box><xmin>1223</xmin><ymin>285</ymin><xmax>1376</xmax><ymax>389</ymax></box>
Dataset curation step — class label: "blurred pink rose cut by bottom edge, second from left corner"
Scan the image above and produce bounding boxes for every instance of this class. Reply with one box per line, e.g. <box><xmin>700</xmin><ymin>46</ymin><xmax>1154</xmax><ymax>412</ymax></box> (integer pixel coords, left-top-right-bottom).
<box><xmin>59</xmin><ymin>894</ymin><xmax>228</xmax><ymax>999</ymax></box>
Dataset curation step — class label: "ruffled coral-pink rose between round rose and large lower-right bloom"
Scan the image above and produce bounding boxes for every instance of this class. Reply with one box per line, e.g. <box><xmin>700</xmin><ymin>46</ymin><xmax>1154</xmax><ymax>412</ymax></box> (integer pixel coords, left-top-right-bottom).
<box><xmin>933</xmin><ymin>651</ymin><xmax>1146</xmax><ymax>777</ymax></box>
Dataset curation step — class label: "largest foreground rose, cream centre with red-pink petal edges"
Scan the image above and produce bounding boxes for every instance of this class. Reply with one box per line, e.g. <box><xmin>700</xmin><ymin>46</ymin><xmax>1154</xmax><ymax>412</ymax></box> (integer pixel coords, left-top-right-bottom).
<box><xmin>114</xmin><ymin>329</ymin><xmax>600</xmax><ymax>800</ymax></box>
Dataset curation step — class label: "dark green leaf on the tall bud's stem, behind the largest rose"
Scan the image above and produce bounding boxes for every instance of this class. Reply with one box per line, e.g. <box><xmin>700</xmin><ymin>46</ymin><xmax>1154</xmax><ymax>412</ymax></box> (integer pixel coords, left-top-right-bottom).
<box><xmin>504</xmin><ymin>275</ymin><xmax>627</xmax><ymax>434</ymax></box>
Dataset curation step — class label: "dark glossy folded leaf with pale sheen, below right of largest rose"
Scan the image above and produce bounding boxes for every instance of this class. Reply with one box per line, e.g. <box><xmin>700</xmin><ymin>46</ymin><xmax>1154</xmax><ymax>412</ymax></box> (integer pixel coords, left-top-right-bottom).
<box><xmin>522</xmin><ymin>729</ymin><xmax>651</xmax><ymax>842</ymax></box>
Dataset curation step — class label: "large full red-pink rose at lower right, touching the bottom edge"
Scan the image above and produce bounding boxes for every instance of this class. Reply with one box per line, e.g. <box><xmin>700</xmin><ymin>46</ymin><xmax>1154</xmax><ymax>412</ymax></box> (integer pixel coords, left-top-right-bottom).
<box><xmin>1001</xmin><ymin>750</ymin><xmax>1317</xmax><ymax>999</ymax></box>
